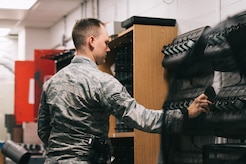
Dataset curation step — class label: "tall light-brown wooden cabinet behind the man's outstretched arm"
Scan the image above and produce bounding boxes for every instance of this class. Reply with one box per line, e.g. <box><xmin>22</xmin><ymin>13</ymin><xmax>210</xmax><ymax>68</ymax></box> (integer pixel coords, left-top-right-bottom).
<box><xmin>100</xmin><ymin>25</ymin><xmax>177</xmax><ymax>164</ymax></box>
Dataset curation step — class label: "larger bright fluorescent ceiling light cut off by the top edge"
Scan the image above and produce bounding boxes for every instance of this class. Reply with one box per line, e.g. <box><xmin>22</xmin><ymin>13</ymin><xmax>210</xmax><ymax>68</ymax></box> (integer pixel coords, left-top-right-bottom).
<box><xmin>0</xmin><ymin>0</ymin><xmax>37</xmax><ymax>10</ymax></box>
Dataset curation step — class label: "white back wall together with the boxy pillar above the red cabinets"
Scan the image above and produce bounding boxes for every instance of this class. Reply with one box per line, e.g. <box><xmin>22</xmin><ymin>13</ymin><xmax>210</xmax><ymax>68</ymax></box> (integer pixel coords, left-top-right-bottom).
<box><xmin>0</xmin><ymin>0</ymin><xmax>246</xmax><ymax>60</ymax></box>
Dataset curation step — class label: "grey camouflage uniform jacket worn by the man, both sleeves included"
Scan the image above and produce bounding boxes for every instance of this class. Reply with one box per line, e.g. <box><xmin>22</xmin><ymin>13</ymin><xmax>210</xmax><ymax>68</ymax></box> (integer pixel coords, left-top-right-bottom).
<box><xmin>38</xmin><ymin>56</ymin><xmax>183</xmax><ymax>163</ymax></box>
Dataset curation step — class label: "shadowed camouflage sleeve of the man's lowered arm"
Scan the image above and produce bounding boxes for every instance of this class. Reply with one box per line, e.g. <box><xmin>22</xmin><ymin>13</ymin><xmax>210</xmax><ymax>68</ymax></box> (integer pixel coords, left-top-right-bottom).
<box><xmin>38</xmin><ymin>91</ymin><xmax>51</xmax><ymax>146</ymax></box>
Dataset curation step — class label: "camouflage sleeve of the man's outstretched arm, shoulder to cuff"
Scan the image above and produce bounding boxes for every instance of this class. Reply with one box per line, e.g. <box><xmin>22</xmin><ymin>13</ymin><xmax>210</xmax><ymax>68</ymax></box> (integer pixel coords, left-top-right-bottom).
<box><xmin>100</xmin><ymin>74</ymin><xmax>184</xmax><ymax>133</ymax></box>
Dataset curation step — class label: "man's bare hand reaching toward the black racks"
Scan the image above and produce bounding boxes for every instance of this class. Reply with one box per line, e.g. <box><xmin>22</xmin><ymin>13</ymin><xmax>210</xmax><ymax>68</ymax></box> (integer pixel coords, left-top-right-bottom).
<box><xmin>187</xmin><ymin>94</ymin><xmax>212</xmax><ymax>118</ymax></box>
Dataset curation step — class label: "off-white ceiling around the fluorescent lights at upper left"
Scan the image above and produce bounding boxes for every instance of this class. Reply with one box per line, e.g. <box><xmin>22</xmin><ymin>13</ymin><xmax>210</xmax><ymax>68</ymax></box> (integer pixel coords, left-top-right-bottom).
<box><xmin>0</xmin><ymin>0</ymin><xmax>84</xmax><ymax>35</ymax></box>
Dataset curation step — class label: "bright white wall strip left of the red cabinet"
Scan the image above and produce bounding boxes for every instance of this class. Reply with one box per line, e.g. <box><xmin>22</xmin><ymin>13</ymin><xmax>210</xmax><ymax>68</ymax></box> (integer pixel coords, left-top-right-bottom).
<box><xmin>0</xmin><ymin>37</ymin><xmax>18</xmax><ymax>140</ymax></box>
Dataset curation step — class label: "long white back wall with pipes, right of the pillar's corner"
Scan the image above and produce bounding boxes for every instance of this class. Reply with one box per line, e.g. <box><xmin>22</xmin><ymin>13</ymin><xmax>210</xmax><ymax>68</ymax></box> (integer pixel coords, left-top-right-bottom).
<box><xmin>48</xmin><ymin>0</ymin><xmax>246</xmax><ymax>48</ymax></box>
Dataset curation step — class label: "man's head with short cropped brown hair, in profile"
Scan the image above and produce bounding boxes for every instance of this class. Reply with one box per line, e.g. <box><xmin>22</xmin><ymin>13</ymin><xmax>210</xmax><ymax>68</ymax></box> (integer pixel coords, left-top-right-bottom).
<box><xmin>72</xmin><ymin>18</ymin><xmax>110</xmax><ymax>64</ymax></box>
